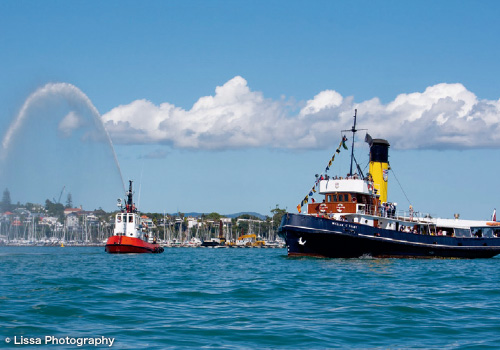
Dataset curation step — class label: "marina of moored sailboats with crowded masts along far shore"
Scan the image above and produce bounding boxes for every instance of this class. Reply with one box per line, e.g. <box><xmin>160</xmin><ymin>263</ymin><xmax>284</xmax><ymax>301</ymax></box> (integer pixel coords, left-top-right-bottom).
<box><xmin>0</xmin><ymin>194</ymin><xmax>284</xmax><ymax>248</ymax></box>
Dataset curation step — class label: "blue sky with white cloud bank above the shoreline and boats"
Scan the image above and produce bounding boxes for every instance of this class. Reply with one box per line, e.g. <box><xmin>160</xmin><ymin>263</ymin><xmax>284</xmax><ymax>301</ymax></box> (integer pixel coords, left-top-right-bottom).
<box><xmin>0</xmin><ymin>0</ymin><xmax>500</xmax><ymax>219</ymax></box>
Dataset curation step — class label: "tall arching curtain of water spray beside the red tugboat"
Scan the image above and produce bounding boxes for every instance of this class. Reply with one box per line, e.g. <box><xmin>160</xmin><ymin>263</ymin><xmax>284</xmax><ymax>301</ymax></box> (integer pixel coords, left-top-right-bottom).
<box><xmin>0</xmin><ymin>83</ymin><xmax>125</xmax><ymax>209</ymax></box>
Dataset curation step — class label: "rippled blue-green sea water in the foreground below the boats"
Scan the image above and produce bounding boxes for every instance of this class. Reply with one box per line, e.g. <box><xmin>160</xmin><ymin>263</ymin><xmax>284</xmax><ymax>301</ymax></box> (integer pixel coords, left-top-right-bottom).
<box><xmin>0</xmin><ymin>247</ymin><xmax>500</xmax><ymax>349</ymax></box>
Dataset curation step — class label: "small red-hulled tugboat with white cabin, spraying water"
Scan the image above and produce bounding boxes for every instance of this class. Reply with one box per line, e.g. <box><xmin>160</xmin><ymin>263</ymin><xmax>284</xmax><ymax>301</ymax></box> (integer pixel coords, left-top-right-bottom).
<box><xmin>105</xmin><ymin>181</ymin><xmax>163</xmax><ymax>254</ymax></box>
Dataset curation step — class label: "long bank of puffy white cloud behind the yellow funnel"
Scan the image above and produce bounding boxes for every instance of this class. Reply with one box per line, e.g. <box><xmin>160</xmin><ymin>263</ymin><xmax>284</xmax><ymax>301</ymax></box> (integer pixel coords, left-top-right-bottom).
<box><xmin>103</xmin><ymin>76</ymin><xmax>500</xmax><ymax>149</ymax></box>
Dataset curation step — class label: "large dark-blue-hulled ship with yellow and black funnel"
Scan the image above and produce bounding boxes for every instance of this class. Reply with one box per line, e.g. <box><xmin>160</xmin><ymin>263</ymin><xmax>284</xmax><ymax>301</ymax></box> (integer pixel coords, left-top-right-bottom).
<box><xmin>278</xmin><ymin>110</ymin><xmax>500</xmax><ymax>259</ymax></box>
